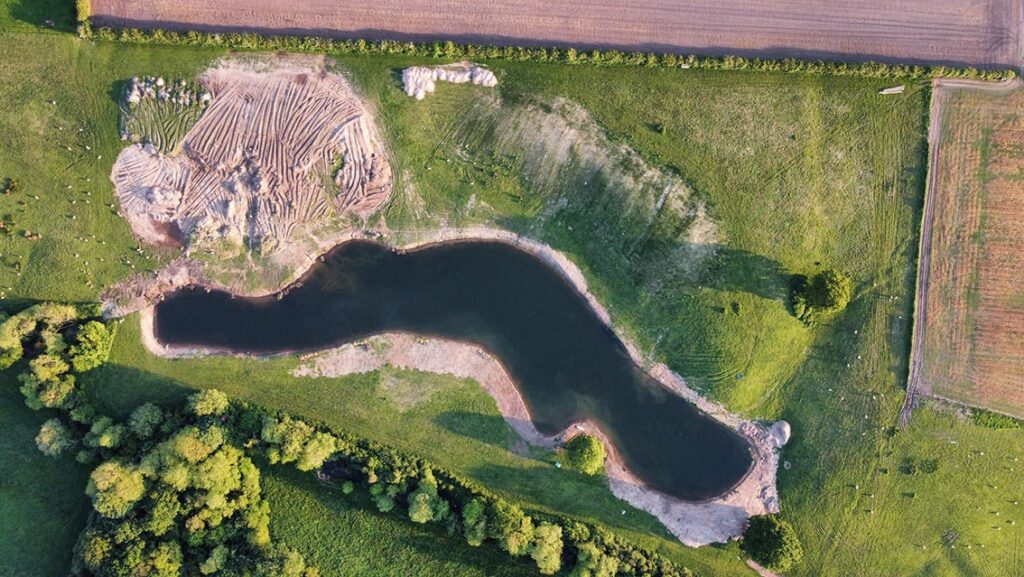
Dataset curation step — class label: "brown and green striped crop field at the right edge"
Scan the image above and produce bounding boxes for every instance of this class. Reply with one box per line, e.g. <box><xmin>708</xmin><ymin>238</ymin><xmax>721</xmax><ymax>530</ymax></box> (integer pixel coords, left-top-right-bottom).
<box><xmin>922</xmin><ymin>88</ymin><xmax>1024</xmax><ymax>416</ymax></box>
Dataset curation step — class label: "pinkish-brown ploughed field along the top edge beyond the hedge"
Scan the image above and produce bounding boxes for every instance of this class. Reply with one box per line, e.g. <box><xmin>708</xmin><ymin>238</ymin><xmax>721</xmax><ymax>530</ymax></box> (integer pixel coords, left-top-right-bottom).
<box><xmin>92</xmin><ymin>0</ymin><xmax>1024</xmax><ymax>66</ymax></box>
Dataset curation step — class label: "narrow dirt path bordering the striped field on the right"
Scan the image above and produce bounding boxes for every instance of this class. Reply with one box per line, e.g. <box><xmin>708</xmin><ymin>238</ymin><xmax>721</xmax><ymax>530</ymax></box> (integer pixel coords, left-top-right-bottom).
<box><xmin>898</xmin><ymin>78</ymin><xmax>1024</xmax><ymax>429</ymax></box>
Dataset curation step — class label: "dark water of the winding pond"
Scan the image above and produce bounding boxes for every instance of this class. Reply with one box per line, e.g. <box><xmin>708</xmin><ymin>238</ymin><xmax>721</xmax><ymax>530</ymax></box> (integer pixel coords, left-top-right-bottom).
<box><xmin>156</xmin><ymin>241</ymin><xmax>752</xmax><ymax>500</ymax></box>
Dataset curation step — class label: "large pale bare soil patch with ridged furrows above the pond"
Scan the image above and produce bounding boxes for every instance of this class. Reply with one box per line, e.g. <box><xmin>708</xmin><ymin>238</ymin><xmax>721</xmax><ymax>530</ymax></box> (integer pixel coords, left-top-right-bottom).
<box><xmin>111</xmin><ymin>57</ymin><xmax>392</xmax><ymax>289</ymax></box>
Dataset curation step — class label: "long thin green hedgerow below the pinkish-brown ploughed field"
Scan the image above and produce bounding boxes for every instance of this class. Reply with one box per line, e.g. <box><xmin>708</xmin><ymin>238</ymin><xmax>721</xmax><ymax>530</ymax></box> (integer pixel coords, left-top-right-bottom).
<box><xmin>79</xmin><ymin>22</ymin><xmax>1017</xmax><ymax>80</ymax></box>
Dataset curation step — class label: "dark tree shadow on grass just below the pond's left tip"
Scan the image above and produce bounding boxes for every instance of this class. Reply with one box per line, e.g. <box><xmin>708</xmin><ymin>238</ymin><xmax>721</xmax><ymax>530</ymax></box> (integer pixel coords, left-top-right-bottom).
<box><xmin>79</xmin><ymin>363</ymin><xmax>195</xmax><ymax>417</ymax></box>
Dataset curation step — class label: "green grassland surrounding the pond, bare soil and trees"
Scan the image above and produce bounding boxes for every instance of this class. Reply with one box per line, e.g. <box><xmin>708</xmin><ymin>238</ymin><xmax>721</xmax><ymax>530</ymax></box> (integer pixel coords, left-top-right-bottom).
<box><xmin>0</xmin><ymin>0</ymin><xmax>1024</xmax><ymax>577</ymax></box>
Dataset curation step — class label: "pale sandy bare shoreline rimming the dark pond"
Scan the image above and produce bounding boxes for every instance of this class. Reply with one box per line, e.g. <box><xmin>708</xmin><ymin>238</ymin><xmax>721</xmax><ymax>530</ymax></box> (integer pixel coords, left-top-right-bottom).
<box><xmin>117</xmin><ymin>226</ymin><xmax>788</xmax><ymax>547</ymax></box>
